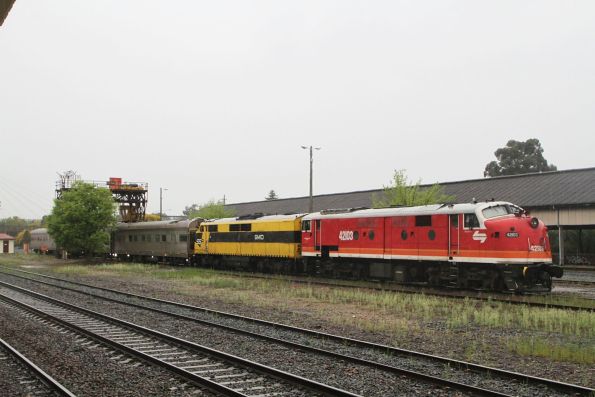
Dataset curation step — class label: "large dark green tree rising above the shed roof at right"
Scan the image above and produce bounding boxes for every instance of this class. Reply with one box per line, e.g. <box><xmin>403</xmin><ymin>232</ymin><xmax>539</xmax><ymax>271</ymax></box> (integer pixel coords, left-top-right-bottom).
<box><xmin>483</xmin><ymin>138</ymin><xmax>557</xmax><ymax>177</ymax></box>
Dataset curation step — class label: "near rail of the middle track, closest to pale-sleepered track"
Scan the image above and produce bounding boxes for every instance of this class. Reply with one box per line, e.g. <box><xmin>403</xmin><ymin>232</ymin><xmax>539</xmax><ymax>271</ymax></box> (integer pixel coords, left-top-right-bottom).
<box><xmin>0</xmin><ymin>268</ymin><xmax>509</xmax><ymax>397</ymax></box>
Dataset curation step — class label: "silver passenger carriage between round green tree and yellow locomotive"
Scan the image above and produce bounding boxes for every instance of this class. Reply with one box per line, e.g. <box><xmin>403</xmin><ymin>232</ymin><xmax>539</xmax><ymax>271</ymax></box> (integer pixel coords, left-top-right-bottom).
<box><xmin>111</xmin><ymin>218</ymin><xmax>202</xmax><ymax>263</ymax></box>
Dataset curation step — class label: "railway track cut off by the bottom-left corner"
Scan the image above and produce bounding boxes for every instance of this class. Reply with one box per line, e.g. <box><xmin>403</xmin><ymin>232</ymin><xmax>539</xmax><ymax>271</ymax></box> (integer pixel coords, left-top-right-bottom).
<box><xmin>0</xmin><ymin>338</ymin><xmax>75</xmax><ymax>397</ymax></box>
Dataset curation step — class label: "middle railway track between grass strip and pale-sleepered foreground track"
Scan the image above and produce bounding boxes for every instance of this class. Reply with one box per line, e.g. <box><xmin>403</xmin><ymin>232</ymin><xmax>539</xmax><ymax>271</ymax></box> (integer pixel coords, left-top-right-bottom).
<box><xmin>2</xmin><ymin>272</ymin><xmax>594</xmax><ymax>396</ymax></box>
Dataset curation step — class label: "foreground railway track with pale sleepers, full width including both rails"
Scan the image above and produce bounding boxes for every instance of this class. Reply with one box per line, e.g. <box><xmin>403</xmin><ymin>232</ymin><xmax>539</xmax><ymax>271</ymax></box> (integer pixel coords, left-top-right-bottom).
<box><xmin>0</xmin><ymin>282</ymin><xmax>357</xmax><ymax>397</ymax></box>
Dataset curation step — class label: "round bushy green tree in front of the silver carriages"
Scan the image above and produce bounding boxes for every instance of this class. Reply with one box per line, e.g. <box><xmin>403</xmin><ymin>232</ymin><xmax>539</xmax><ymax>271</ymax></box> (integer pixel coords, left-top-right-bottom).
<box><xmin>47</xmin><ymin>182</ymin><xmax>116</xmax><ymax>255</ymax></box>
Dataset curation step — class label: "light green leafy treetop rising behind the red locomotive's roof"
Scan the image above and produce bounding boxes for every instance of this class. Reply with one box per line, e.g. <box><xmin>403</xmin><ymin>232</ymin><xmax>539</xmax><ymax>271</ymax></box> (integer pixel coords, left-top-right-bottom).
<box><xmin>372</xmin><ymin>170</ymin><xmax>455</xmax><ymax>208</ymax></box>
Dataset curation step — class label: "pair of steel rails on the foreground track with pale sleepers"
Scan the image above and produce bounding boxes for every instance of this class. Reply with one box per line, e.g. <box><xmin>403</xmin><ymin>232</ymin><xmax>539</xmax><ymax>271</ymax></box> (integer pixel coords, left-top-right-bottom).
<box><xmin>0</xmin><ymin>281</ymin><xmax>359</xmax><ymax>397</ymax></box>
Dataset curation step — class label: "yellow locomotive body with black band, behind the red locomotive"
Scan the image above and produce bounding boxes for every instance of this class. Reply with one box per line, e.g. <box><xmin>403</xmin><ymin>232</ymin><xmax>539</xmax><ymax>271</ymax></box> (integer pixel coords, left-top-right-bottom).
<box><xmin>194</xmin><ymin>214</ymin><xmax>304</xmax><ymax>260</ymax></box>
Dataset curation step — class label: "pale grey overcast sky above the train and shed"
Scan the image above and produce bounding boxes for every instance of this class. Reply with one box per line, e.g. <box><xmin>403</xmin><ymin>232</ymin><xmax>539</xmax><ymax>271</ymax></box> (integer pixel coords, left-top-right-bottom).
<box><xmin>0</xmin><ymin>0</ymin><xmax>595</xmax><ymax>218</ymax></box>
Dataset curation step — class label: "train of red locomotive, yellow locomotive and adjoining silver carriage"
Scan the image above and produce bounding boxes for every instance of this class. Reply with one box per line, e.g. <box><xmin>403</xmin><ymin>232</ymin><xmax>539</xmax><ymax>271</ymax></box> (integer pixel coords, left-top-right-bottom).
<box><xmin>111</xmin><ymin>202</ymin><xmax>562</xmax><ymax>292</ymax></box>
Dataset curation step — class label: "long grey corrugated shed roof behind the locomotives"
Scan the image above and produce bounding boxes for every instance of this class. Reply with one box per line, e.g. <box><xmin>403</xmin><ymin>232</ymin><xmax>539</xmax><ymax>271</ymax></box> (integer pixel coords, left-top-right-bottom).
<box><xmin>226</xmin><ymin>168</ymin><xmax>595</xmax><ymax>215</ymax></box>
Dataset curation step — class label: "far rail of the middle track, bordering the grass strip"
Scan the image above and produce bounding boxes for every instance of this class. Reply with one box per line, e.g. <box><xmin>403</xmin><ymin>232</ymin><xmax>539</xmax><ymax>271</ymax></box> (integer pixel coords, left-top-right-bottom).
<box><xmin>6</xmin><ymin>270</ymin><xmax>595</xmax><ymax>395</ymax></box>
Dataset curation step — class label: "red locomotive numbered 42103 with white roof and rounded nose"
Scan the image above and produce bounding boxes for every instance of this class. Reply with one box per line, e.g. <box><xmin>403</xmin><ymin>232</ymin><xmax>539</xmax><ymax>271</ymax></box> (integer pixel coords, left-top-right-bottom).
<box><xmin>302</xmin><ymin>202</ymin><xmax>562</xmax><ymax>292</ymax></box>
